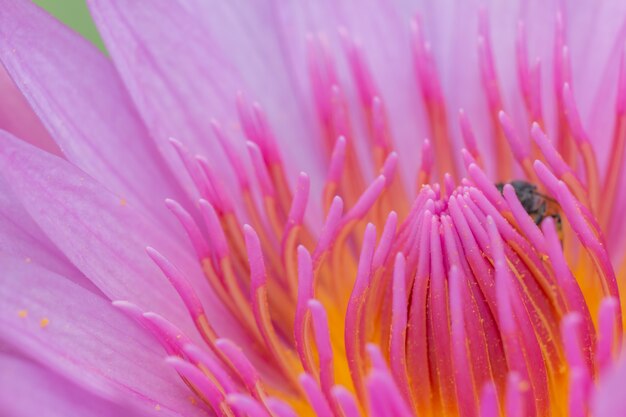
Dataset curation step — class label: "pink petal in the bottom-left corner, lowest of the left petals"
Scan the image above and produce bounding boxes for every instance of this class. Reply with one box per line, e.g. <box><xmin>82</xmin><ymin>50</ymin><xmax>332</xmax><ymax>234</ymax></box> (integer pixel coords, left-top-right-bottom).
<box><xmin>0</xmin><ymin>354</ymin><xmax>143</xmax><ymax>417</ymax></box>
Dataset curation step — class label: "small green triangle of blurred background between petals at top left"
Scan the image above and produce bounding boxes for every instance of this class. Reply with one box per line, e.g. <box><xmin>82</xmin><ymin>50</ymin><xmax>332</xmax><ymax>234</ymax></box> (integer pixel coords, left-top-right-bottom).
<box><xmin>32</xmin><ymin>0</ymin><xmax>105</xmax><ymax>51</ymax></box>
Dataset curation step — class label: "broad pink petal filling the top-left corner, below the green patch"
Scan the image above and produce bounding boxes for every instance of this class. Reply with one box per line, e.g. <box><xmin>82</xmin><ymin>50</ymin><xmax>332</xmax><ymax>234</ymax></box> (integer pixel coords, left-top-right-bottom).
<box><xmin>0</xmin><ymin>0</ymin><xmax>190</xmax><ymax>231</ymax></box>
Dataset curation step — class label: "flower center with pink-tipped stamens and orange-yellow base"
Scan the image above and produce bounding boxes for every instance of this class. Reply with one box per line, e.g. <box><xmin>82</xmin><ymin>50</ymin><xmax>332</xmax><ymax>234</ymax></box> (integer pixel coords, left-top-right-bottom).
<box><xmin>118</xmin><ymin>7</ymin><xmax>626</xmax><ymax>416</ymax></box>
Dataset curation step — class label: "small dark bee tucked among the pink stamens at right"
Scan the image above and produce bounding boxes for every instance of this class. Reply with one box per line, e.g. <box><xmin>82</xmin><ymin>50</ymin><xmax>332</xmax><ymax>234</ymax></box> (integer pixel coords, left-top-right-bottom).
<box><xmin>496</xmin><ymin>180</ymin><xmax>562</xmax><ymax>234</ymax></box>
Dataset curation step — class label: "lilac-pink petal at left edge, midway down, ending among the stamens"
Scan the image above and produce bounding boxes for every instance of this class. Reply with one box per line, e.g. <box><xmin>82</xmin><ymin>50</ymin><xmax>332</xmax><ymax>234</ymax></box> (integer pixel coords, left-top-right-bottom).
<box><xmin>0</xmin><ymin>132</ymin><xmax>236</xmax><ymax>336</ymax></box>
